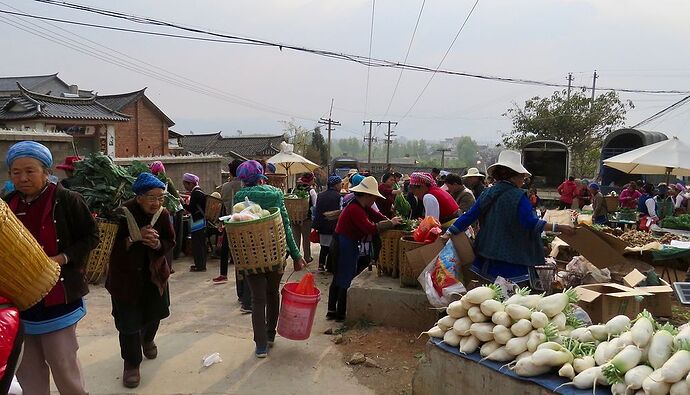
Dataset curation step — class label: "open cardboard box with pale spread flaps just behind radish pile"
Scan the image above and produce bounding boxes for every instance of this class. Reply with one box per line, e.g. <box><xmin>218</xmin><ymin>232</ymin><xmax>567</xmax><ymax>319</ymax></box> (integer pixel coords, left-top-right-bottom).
<box><xmin>575</xmin><ymin>283</ymin><xmax>652</xmax><ymax>324</ymax></box>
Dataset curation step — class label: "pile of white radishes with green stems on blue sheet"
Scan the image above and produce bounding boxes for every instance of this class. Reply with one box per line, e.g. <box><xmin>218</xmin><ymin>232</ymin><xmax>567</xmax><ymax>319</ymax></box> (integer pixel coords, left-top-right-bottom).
<box><xmin>416</xmin><ymin>286</ymin><xmax>690</xmax><ymax>395</ymax></box>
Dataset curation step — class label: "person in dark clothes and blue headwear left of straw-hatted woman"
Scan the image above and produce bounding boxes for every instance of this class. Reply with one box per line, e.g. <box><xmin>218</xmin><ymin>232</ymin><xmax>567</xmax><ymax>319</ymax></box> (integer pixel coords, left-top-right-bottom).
<box><xmin>312</xmin><ymin>175</ymin><xmax>343</xmax><ymax>271</ymax></box>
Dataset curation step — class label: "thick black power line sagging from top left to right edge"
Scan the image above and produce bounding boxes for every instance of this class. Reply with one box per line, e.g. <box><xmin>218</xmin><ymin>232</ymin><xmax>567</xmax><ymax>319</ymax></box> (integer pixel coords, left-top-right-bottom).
<box><xmin>22</xmin><ymin>0</ymin><xmax>690</xmax><ymax>94</ymax></box>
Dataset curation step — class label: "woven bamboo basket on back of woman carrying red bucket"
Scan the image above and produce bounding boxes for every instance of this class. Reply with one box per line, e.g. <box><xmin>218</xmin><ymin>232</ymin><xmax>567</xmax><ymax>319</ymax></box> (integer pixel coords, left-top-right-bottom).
<box><xmin>225</xmin><ymin>207</ymin><xmax>287</xmax><ymax>274</ymax></box>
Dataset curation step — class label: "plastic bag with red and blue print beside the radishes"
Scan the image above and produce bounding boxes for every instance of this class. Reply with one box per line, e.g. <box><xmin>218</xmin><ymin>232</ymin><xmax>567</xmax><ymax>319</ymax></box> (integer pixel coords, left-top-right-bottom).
<box><xmin>417</xmin><ymin>242</ymin><xmax>467</xmax><ymax>307</ymax></box>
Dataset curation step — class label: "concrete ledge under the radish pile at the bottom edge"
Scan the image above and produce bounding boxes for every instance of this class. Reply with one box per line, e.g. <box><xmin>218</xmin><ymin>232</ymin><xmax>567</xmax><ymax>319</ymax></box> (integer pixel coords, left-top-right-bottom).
<box><xmin>408</xmin><ymin>342</ymin><xmax>554</xmax><ymax>395</ymax></box>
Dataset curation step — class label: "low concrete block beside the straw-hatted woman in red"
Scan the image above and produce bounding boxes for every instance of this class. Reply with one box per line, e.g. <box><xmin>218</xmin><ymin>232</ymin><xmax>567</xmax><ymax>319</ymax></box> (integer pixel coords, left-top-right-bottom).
<box><xmin>347</xmin><ymin>270</ymin><xmax>436</xmax><ymax>332</ymax></box>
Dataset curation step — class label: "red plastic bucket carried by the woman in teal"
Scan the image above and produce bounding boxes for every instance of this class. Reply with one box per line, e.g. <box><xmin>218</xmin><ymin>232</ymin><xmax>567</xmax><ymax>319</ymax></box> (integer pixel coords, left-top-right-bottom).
<box><xmin>278</xmin><ymin>283</ymin><xmax>321</xmax><ymax>340</ymax></box>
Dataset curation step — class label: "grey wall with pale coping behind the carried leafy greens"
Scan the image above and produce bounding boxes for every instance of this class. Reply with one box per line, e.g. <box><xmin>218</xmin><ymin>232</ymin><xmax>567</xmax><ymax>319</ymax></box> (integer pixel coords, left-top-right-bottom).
<box><xmin>115</xmin><ymin>155</ymin><xmax>220</xmax><ymax>194</ymax></box>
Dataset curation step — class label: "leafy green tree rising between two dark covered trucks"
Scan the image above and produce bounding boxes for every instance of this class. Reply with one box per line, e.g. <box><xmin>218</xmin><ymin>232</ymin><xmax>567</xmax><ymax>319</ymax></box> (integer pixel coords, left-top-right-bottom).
<box><xmin>503</xmin><ymin>90</ymin><xmax>634</xmax><ymax>177</ymax></box>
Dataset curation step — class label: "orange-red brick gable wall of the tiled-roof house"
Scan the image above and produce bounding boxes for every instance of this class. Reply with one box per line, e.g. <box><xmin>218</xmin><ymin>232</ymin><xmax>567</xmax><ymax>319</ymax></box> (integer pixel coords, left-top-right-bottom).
<box><xmin>115</xmin><ymin>99</ymin><xmax>168</xmax><ymax>158</ymax></box>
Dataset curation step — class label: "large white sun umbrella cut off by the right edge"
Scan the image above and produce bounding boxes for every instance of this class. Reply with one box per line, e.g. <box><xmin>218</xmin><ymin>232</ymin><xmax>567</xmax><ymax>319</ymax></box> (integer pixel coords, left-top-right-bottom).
<box><xmin>604</xmin><ymin>137</ymin><xmax>690</xmax><ymax>177</ymax></box>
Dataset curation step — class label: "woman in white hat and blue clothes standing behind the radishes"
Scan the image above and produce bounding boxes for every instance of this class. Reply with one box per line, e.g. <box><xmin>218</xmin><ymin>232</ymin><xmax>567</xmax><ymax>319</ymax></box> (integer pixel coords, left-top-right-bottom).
<box><xmin>448</xmin><ymin>150</ymin><xmax>574</xmax><ymax>286</ymax></box>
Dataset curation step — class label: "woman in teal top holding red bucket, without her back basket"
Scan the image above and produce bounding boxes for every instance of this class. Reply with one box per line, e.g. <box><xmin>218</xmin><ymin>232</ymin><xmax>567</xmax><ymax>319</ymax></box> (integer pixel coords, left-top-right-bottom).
<box><xmin>235</xmin><ymin>160</ymin><xmax>306</xmax><ymax>358</ymax></box>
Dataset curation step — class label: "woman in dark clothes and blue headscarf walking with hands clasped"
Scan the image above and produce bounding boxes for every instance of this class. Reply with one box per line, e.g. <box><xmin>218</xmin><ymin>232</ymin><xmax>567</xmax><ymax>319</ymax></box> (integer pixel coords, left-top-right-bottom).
<box><xmin>105</xmin><ymin>173</ymin><xmax>175</xmax><ymax>388</ymax></box>
